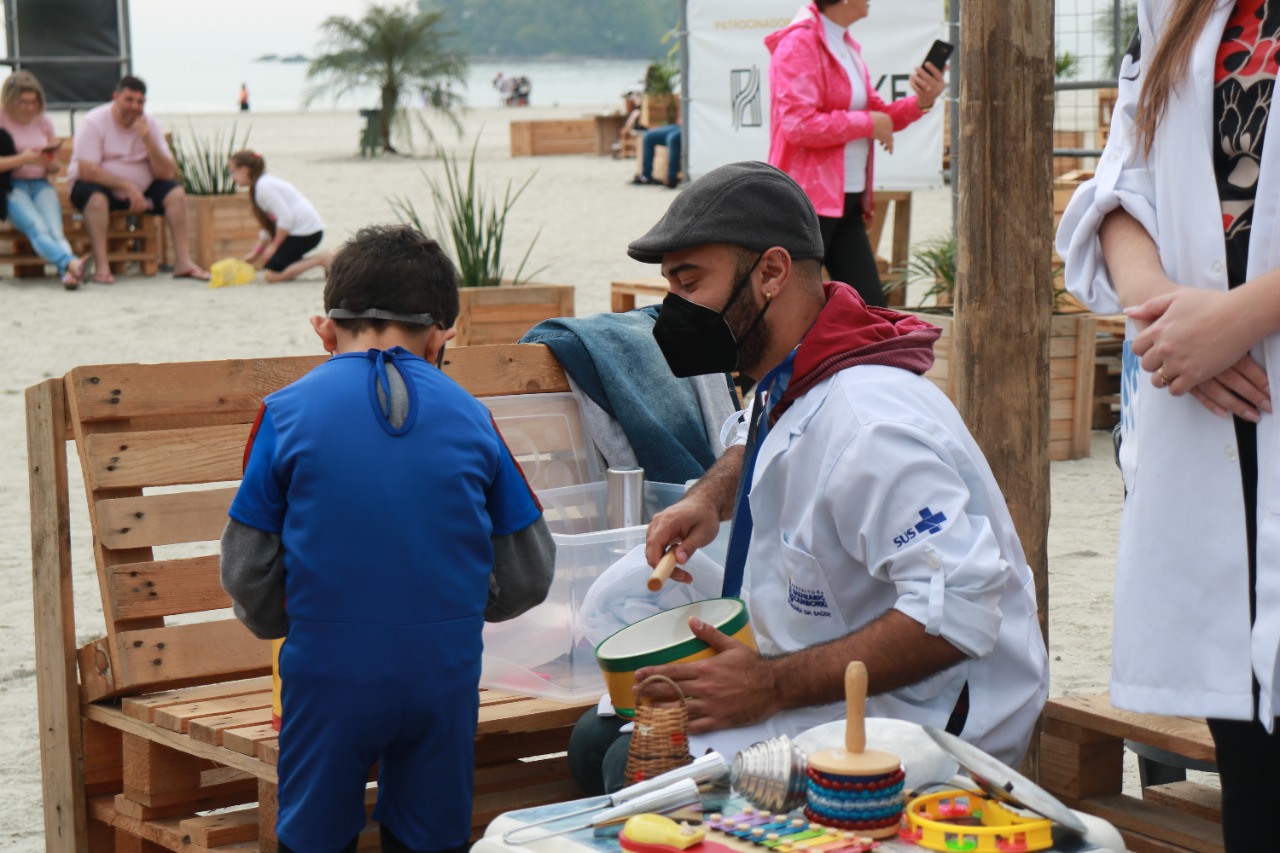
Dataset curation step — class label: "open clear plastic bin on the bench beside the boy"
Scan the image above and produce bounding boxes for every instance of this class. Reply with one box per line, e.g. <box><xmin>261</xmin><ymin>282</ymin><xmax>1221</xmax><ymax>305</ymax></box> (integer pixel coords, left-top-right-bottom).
<box><xmin>480</xmin><ymin>482</ymin><xmax>730</xmax><ymax>702</ymax></box>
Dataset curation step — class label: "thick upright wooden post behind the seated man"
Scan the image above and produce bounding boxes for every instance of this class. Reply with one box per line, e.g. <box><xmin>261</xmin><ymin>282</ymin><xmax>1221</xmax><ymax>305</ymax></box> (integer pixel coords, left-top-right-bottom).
<box><xmin>952</xmin><ymin>0</ymin><xmax>1053</xmax><ymax>756</ymax></box>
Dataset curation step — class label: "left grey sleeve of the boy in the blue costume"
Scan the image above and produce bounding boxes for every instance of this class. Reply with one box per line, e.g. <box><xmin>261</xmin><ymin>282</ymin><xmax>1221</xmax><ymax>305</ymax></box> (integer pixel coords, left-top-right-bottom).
<box><xmin>221</xmin><ymin>519</ymin><xmax>289</xmax><ymax>639</ymax></box>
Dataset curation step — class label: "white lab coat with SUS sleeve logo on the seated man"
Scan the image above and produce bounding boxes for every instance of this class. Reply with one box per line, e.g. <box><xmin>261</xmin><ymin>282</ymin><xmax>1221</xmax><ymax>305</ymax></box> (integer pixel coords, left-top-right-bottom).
<box><xmin>694</xmin><ymin>365</ymin><xmax>1048</xmax><ymax>767</ymax></box>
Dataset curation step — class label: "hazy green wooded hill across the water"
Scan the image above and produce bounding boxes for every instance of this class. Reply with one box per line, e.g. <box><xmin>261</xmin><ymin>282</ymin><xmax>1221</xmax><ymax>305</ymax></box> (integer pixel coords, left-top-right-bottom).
<box><xmin>419</xmin><ymin>0</ymin><xmax>680</xmax><ymax>59</ymax></box>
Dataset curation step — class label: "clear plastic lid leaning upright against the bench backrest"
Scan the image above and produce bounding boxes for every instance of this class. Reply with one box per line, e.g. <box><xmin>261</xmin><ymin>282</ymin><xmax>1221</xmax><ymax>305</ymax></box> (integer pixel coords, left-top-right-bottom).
<box><xmin>480</xmin><ymin>393</ymin><xmax>604</xmax><ymax>492</ymax></box>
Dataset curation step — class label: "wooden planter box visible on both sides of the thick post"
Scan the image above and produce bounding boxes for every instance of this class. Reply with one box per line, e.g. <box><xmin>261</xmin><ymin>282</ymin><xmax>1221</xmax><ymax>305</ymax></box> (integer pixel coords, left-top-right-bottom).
<box><xmin>915</xmin><ymin>311</ymin><xmax>1096</xmax><ymax>460</ymax></box>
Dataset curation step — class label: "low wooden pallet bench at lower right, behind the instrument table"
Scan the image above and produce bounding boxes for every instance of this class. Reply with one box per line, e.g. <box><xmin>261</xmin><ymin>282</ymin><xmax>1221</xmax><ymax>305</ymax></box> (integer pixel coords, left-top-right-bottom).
<box><xmin>1041</xmin><ymin>695</ymin><xmax>1222</xmax><ymax>853</ymax></box>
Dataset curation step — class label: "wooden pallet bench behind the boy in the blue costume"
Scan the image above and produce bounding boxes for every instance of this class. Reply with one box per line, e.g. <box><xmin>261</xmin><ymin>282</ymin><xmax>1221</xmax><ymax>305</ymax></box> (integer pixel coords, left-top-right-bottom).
<box><xmin>27</xmin><ymin>345</ymin><xmax>595</xmax><ymax>853</ymax></box>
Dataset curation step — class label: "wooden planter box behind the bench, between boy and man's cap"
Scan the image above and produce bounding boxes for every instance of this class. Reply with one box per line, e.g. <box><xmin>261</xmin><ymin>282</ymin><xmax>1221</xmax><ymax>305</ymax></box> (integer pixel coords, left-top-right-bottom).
<box><xmin>453</xmin><ymin>283</ymin><xmax>573</xmax><ymax>347</ymax></box>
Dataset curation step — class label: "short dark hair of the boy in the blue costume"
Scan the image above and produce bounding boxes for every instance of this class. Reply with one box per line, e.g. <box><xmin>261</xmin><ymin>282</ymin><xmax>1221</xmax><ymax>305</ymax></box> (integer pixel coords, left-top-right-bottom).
<box><xmin>324</xmin><ymin>225</ymin><xmax>458</xmax><ymax>334</ymax></box>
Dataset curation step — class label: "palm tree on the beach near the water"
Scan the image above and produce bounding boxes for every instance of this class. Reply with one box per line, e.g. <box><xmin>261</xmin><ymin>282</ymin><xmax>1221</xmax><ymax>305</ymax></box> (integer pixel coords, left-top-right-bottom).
<box><xmin>306</xmin><ymin>4</ymin><xmax>467</xmax><ymax>152</ymax></box>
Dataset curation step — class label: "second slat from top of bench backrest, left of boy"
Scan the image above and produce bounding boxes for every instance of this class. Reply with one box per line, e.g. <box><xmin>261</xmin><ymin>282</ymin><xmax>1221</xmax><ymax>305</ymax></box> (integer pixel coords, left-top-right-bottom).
<box><xmin>82</xmin><ymin>424</ymin><xmax>250</xmax><ymax>492</ymax></box>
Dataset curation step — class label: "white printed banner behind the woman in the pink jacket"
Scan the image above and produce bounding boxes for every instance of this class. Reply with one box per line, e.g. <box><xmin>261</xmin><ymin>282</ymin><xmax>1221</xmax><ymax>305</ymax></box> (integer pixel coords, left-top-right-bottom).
<box><xmin>685</xmin><ymin>0</ymin><xmax>950</xmax><ymax>190</ymax></box>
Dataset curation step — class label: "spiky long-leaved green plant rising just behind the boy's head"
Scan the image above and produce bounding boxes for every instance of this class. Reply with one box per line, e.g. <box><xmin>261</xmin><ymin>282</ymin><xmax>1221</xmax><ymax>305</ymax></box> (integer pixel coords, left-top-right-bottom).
<box><xmin>390</xmin><ymin>138</ymin><xmax>541</xmax><ymax>287</ymax></box>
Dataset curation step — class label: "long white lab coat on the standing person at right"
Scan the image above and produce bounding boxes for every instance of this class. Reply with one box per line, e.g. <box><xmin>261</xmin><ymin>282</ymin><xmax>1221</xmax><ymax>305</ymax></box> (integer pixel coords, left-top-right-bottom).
<box><xmin>1057</xmin><ymin>0</ymin><xmax>1280</xmax><ymax>725</ymax></box>
